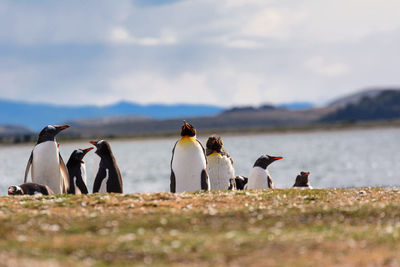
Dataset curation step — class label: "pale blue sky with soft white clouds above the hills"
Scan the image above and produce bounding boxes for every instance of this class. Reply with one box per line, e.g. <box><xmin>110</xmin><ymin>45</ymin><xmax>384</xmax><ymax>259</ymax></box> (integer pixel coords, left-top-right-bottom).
<box><xmin>0</xmin><ymin>0</ymin><xmax>400</xmax><ymax>106</ymax></box>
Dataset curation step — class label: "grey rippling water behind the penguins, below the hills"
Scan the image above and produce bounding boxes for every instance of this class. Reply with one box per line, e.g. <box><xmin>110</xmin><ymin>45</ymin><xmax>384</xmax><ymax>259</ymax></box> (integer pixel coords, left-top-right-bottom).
<box><xmin>0</xmin><ymin>129</ymin><xmax>400</xmax><ymax>195</ymax></box>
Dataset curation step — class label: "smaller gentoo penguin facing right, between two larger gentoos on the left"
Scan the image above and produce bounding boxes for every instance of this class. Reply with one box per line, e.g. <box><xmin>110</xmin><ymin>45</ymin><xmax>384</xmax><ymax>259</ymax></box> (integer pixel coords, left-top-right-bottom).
<box><xmin>67</xmin><ymin>147</ymin><xmax>93</xmax><ymax>194</ymax></box>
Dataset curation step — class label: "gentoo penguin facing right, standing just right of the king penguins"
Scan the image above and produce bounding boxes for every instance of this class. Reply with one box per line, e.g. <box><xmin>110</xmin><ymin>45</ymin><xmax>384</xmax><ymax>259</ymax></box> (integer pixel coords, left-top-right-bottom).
<box><xmin>247</xmin><ymin>155</ymin><xmax>283</xmax><ymax>189</ymax></box>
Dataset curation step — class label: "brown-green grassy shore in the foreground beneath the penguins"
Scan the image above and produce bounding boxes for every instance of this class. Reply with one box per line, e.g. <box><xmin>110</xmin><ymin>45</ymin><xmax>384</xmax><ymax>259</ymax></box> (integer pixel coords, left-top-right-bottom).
<box><xmin>0</xmin><ymin>188</ymin><xmax>400</xmax><ymax>266</ymax></box>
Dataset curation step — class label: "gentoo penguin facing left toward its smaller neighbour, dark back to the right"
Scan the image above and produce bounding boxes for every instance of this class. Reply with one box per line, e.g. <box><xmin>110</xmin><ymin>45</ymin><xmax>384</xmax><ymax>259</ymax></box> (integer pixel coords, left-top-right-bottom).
<box><xmin>90</xmin><ymin>140</ymin><xmax>122</xmax><ymax>193</ymax></box>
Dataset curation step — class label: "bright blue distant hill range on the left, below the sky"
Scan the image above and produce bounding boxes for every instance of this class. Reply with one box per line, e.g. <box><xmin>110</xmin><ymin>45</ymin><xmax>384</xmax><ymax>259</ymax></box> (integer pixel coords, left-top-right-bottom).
<box><xmin>0</xmin><ymin>100</ymin><xmax>223</xmax><ymax>131</ymax></box>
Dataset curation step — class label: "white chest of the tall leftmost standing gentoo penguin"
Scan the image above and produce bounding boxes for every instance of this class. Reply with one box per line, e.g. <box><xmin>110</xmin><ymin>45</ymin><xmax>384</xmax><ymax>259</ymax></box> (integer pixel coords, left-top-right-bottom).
<box><xmin>32</xmin><ymin>141</ymin><xmax>62</xmax><ymax>194</ymax></box>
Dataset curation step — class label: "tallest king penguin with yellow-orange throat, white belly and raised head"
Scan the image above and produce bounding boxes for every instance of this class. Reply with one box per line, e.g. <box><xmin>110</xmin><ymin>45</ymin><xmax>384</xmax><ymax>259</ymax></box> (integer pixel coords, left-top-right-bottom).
<box><xmin>170</xmin><ymin>121</ymin><xmax>210</xmax><ymax>193</ymax></box>
